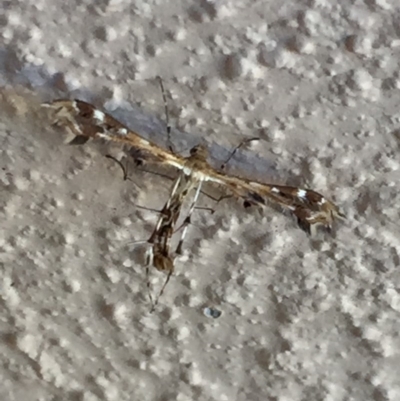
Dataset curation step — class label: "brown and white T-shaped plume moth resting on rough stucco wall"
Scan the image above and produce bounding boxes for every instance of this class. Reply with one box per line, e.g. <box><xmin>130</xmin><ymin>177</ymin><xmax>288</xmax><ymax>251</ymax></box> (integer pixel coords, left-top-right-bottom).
<box><xmin>43</xmin><ymin>96</ymin><xmax>344</xmax><ymax>311</ymax></box>
